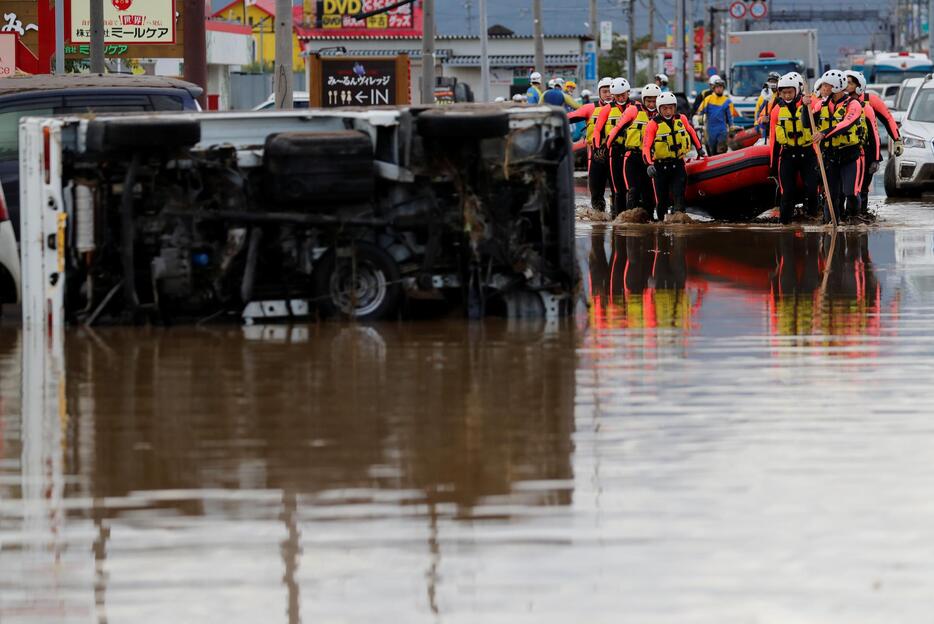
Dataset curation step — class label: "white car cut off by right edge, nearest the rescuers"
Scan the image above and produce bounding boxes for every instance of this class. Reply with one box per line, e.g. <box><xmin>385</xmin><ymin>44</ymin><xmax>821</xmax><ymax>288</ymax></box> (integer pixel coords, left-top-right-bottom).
<box><xmin>884</xmin><ymin>75</ymin><xmax>934</xmax><ymax>197</ymax></box>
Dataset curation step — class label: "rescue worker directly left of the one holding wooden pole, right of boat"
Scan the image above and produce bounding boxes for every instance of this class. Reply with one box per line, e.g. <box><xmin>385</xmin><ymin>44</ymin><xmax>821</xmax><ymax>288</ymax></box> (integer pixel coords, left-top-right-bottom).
<box><xmin>769</xmin><ymin>74</ymin><xmax>820</xmax><ymax>224</ymax></box>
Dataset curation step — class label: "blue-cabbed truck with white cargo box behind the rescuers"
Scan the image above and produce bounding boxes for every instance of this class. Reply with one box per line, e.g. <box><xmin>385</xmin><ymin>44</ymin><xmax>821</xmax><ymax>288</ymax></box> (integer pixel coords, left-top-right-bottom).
<box><xmin>726</xmin><ymin>29</ymin><xmax>820</xmax><ymax>127</ymax></box>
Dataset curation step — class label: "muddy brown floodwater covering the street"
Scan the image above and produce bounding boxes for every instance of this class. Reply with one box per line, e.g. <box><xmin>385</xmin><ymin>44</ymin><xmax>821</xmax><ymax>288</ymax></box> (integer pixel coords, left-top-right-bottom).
<box><xmin>0</xmin><ymin>212</ymin><xmax>934</xmax><ymax>624</ymax></box>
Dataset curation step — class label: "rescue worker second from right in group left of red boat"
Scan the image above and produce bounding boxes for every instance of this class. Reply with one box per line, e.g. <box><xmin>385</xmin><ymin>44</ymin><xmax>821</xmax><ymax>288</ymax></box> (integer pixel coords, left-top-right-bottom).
<box><xmin>607</xmin><ymin>84</ymin><xmax>662</xmax><ymax>213</ymax></box>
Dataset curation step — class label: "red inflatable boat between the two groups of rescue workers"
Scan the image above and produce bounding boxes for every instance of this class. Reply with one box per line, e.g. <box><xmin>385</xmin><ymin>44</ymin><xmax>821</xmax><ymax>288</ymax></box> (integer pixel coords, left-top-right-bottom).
<box><xmin>684</xmin><ymin>145</ymin><xmax>776</xmax><ymax>218</ymax></box>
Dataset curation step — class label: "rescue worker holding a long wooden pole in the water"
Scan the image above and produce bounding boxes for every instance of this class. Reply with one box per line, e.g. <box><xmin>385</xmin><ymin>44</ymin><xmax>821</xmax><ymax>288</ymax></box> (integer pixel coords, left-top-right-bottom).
<box><xmin>805</xmin><ymin>69</ymin><xmax>868</xmax><ymax>223</ymax></box>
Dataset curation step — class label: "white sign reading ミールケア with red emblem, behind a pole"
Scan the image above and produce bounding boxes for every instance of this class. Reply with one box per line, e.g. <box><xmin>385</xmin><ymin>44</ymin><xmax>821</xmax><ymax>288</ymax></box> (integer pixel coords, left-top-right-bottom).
<box><xmin>66</xmin><ymin>0</ymin><xmax>175</xmax><ymax>45</ymax></box>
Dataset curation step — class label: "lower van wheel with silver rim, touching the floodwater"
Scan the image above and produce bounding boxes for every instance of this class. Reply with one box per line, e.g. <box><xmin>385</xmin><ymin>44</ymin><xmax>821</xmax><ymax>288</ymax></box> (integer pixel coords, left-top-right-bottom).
<box><xmin>312</xmin><ymin>242</ymin><xmax>403</xmax><ymax>321</ymax></box>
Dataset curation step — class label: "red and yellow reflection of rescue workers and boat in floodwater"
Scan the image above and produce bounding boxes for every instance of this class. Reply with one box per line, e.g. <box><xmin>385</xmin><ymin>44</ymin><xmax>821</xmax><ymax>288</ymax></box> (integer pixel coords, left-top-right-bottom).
<box><xmin>589</xmin><ymin>228</ymin><xmax>898</xmax><ymax>355</ymax></box>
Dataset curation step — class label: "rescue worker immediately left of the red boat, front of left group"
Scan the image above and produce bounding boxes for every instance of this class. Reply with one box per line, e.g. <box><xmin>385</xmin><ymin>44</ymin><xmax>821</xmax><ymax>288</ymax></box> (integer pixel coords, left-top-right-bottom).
<box><xmin>642</xmin><ymin>93</ymin><xmax>704</xmax><ymax>220</ymax></box>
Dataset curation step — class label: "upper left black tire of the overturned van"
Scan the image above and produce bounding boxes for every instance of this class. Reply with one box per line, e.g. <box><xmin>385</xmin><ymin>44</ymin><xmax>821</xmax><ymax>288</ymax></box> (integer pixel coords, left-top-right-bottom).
<box><xmin>87</xmin><ymin>118</ymin><xmax>201</xmax><ymax>152</ymax></box>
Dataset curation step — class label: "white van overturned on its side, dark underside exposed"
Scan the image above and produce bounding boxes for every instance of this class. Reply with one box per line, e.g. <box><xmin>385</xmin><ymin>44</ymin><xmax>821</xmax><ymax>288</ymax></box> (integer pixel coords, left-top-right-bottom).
<box><xmin>20</xmin><ymin>106</ymin><xmax>578</xmax><ymax>323</ymax></box>
